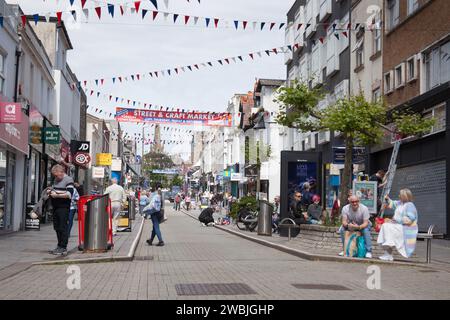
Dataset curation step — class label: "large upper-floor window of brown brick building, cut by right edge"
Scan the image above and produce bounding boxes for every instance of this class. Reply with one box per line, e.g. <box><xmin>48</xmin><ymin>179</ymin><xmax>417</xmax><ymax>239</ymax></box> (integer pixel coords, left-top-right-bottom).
<box><xmin>425</xmin><ymin>41</ymin><xmax>450</xmax><ymax>91</ymax></box>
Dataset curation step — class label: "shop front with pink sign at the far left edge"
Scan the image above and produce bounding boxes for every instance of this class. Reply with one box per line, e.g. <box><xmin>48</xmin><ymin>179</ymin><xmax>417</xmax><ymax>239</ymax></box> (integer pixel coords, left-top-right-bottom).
<box><xmin>0</xmin><ymin>104</ymin><xmax>29</xmax><ymax>234</ymax></box>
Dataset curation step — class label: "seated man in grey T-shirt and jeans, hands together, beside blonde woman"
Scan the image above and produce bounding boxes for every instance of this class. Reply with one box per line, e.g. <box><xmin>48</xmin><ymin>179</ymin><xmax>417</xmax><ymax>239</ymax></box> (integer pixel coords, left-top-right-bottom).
<box><xmin>339</xmin><ymin>196</ymin><xmax>372</xmax><ymax>259</ymax></box>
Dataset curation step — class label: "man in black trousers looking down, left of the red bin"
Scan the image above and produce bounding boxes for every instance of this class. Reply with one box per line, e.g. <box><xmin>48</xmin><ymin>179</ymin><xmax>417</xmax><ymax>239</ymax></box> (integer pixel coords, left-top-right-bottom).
<box><xmin>47</xmin><ymin>164</ymin><xmax>75</xmax><ymax>255</ymax></box>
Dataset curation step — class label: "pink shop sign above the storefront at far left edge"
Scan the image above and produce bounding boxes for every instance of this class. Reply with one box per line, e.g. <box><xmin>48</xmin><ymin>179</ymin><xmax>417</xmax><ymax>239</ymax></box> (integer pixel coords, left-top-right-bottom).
<box><xmin>0</xmin><ymin>115</ymin><xmax>29</xmax><ymax>154</ymax></box>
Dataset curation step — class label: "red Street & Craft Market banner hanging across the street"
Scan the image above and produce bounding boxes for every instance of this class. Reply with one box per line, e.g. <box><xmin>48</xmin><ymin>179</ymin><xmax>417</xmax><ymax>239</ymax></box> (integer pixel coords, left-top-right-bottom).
<box><xmin>115</xmin><ymin>108</ymin><xmax>232</xmax><ymax>127</ymax></box>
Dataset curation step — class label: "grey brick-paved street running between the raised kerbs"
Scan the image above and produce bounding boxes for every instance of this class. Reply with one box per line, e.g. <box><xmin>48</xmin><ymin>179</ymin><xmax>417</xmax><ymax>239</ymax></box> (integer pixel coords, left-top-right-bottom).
<box><xmin>0</xmin><ymin>206</ymin><xmax>450</xmax><ymax>300</ymax></box>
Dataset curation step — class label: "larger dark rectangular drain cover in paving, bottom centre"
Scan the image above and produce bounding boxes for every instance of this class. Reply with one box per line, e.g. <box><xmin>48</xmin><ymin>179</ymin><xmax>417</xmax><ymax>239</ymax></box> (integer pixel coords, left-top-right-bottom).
<box><xmin>175</xmin><ymin>283</ymin><xmax>256</xmax><ymax>296</ymax></box>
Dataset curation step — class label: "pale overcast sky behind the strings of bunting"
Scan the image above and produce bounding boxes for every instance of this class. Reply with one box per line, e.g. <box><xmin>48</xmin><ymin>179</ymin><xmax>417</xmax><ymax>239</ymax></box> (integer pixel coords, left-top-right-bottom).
<box><xmin>6</xmin><ymin>0</ymin><xmax>294</xmax><ymax>158</ymax></box>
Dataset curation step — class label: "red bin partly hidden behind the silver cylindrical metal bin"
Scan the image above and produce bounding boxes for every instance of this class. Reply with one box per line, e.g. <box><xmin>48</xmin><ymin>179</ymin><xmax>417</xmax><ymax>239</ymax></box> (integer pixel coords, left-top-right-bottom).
<box><xmin>78</xmin><ymin>195</ymin><xmax>113</xmax><ymax>252</ymax></box>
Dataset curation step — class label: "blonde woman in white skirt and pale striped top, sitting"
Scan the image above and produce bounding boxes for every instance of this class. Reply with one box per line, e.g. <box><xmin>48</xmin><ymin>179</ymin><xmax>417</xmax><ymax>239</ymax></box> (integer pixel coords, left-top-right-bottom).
<box><xmin>377</xmin><ymin>189</ymin><xmax>419</xmax><ymax>261</ymax></box>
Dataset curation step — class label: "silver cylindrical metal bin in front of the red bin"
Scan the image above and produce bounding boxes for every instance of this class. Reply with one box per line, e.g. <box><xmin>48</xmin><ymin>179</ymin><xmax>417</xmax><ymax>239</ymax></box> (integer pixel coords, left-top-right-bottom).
<box><xmin>83</xmin><ymin>195</ymin><xmax>109</xmax><ymax>252</ymax></box>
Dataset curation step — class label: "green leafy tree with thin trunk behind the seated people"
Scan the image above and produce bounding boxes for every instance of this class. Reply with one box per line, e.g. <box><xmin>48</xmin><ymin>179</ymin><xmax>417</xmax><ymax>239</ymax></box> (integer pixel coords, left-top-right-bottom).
<box><xmin>276</xmin><ymin>82</ymin><xmax>434</xmax><ymax>214</ymax></box>
